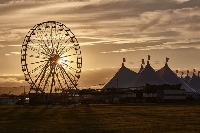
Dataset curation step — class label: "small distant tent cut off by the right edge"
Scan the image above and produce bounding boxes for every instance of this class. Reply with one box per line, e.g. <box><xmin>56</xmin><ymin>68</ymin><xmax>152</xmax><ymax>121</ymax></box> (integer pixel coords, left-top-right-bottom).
<box><xmin>188</xmin><ymin>73</ymin><xmax>200</xmax><ymax>93</ymax></box>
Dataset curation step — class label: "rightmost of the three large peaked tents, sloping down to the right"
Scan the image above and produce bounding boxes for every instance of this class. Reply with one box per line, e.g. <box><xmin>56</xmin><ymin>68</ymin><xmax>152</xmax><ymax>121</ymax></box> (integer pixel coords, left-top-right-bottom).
<box><xmin>157</xmin><ymin>63</ymin><xmax>195</xmax><ymax>92</ymax></box>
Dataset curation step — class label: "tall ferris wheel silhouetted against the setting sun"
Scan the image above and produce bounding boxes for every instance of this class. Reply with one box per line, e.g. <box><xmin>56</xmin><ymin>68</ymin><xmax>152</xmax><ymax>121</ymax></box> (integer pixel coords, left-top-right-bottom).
<box><xmin>21</xmin><ymin>21</ymin><xmax>82</xmax><ymax>93</ymax></box>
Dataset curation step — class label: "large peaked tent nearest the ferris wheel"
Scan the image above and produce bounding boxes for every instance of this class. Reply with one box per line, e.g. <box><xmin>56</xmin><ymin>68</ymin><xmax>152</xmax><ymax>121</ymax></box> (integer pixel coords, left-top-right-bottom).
<box><xmin>103</xmin><ymin>63</ymin><xmax>138</xmax><ymax>89</ymax></box>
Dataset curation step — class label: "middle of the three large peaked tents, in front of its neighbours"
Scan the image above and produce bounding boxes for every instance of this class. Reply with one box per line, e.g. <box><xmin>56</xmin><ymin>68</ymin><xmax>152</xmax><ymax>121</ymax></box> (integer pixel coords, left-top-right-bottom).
<box><xmin>125</xmin><ymin>61</ymin><xmax>166</xmax><ymax>87</ymax></box>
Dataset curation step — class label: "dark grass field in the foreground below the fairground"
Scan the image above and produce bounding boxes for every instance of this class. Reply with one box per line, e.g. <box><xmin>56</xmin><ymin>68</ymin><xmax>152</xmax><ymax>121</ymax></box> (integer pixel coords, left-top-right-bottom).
<box><xmin>0</xmin><ymin>104</ymin><xmax>200</xmax><ymax>133</ymax></box>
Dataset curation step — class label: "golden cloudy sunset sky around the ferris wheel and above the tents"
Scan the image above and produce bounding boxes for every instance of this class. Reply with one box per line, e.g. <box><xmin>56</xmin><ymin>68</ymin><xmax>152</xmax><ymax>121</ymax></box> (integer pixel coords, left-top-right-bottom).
<box><xmin>0</xmin><ymin>0</ymin><xmax>200</xmax><ymax>92</ymax></box>
